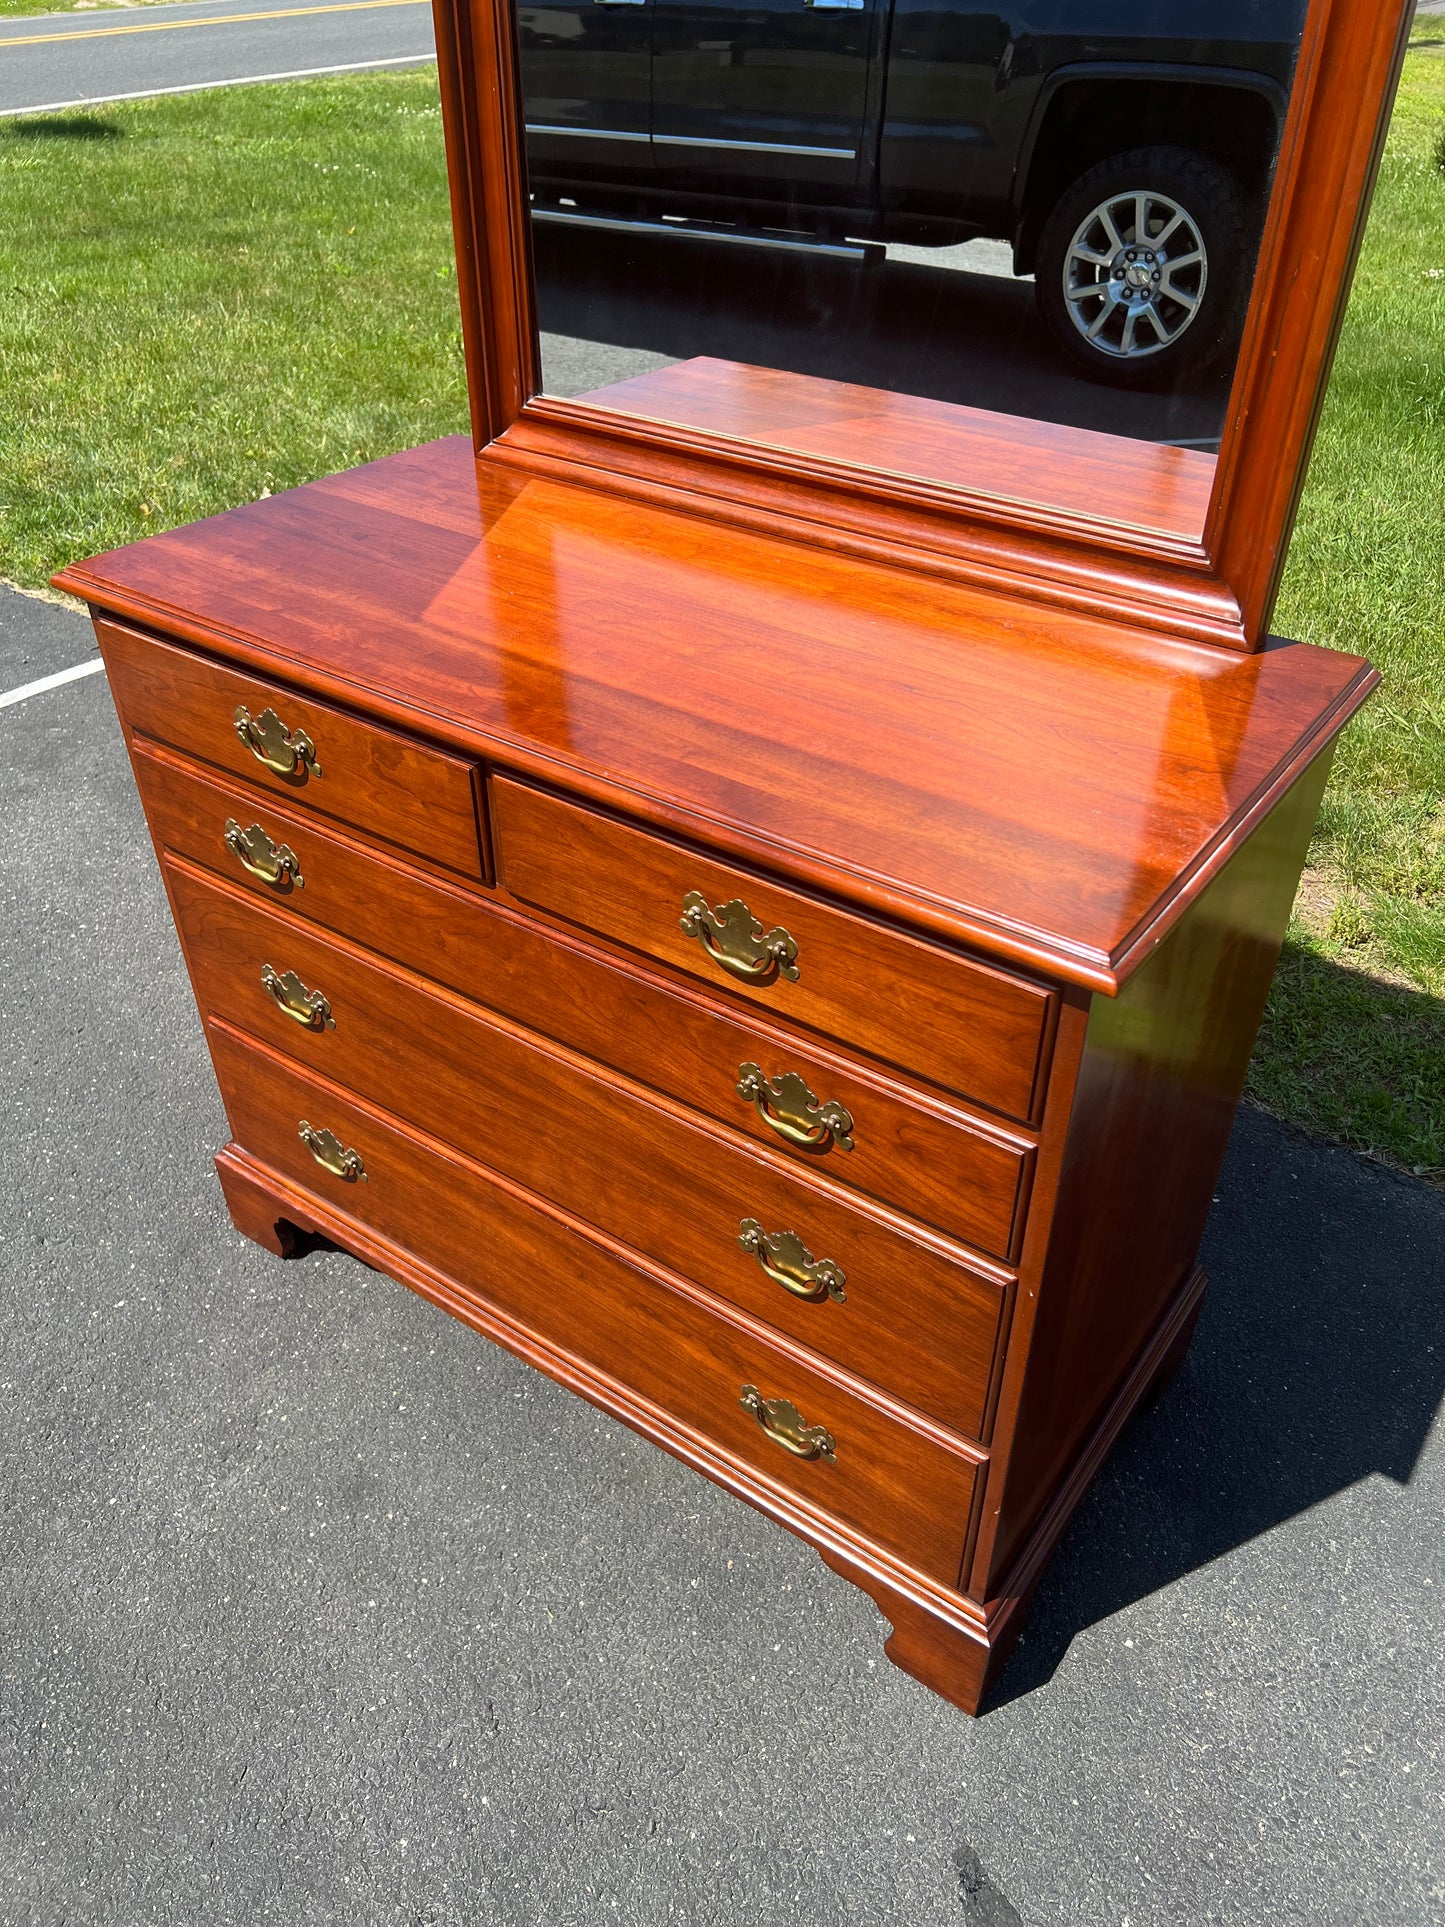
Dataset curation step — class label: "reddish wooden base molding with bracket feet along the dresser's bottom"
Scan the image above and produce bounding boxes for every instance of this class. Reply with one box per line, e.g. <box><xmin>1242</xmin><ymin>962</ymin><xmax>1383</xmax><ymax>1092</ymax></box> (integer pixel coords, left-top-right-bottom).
<box><xmin>216</xmin><ymin>1143</ymin><xmax>1206</xmax><ymax>1715</ymax></box>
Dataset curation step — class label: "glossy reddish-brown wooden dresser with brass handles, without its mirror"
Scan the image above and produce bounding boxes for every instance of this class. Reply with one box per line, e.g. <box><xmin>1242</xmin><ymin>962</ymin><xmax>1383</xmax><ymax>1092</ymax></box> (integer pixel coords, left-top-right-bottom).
<box><xmin>60</xmin><ymin>439</ymin><xmax>1374</xmax><ymax>1711</ymax></box>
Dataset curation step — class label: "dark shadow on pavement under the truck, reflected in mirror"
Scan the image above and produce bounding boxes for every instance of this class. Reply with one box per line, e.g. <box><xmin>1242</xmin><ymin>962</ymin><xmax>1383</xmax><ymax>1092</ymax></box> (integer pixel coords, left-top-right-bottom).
<box><xmin>534</xmin><ymin>227</ymin><xmax>1227</xmax><ymax>441</ymax></box>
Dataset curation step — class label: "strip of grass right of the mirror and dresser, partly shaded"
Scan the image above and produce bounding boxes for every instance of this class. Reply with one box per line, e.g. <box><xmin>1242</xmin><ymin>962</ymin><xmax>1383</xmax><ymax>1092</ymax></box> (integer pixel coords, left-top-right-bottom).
<box><xmin>1250</xmin><ymin>17</ymin><xmax>1445</xmax><ymax>1177</ymax></box>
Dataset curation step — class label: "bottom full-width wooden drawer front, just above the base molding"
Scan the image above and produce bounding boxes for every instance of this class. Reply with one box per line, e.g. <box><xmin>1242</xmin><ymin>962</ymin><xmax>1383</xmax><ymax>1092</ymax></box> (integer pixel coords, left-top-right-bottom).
<box><xmin>208</xmin><ymin>1021</ymin><xmax>977</xmax><ymax>1586</ymax></box>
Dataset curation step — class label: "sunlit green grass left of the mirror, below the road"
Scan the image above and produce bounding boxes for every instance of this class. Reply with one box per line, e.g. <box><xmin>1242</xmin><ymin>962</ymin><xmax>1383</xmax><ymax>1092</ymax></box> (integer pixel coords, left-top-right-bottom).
<box><xmin>0</xmin><ymin>69</ymin><xmax>466</xmax><ymax>584</ymax></box>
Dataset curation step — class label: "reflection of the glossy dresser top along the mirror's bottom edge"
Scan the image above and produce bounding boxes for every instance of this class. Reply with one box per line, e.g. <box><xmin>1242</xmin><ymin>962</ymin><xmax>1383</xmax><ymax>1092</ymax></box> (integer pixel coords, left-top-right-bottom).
<box><xmin>580</xmin><ymin>355</ymin><xmax>1214</xmax><ymax>543</ymax></box>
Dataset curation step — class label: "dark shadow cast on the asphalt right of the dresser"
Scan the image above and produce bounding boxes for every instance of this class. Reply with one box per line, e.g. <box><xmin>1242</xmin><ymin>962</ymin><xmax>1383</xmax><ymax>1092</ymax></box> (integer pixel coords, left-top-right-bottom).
<box><xmin>983</xmin><ymin>1108</ymin><xmax>1445</xmax><ymax>1715</ymax></box>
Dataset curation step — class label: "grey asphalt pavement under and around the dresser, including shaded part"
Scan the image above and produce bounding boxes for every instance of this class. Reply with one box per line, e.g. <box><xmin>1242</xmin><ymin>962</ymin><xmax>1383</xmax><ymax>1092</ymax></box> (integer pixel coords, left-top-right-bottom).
<box><xmin>0</xmin><ymin>592</ymin><xmax>1445</xmax><ymax>1927</ymax></box>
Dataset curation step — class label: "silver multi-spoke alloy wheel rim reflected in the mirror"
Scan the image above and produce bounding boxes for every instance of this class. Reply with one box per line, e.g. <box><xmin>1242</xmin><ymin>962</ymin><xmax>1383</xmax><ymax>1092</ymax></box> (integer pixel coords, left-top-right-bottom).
<box><xmin>1064</xmin><ymin>189</ymin><xmax>1210</xmax><ymax>360</ymax></box>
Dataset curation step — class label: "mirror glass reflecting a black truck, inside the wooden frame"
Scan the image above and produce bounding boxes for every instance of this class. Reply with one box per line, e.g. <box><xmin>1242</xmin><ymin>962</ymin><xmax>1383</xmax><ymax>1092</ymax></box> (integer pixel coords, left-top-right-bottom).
<box><xmin>518</xmin><ymin>0</ymin><xmax>1306</xmax><ymax>538</ymax></box>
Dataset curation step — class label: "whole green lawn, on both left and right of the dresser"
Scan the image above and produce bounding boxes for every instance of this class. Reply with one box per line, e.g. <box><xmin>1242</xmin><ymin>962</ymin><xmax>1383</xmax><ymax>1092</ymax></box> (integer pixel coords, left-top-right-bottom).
<box><xmin>0</xmin><ymin>52</ymin><xmax>1445</xmax><ymax>1179</ymax></box>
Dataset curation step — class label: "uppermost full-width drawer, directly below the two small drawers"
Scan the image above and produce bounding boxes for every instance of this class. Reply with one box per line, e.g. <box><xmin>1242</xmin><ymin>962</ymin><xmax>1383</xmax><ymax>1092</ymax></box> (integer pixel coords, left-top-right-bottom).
<box><xmin>135</xmin><ymin>746</ymin><xmax>1033</xmax><ymax>1260</ymax></box>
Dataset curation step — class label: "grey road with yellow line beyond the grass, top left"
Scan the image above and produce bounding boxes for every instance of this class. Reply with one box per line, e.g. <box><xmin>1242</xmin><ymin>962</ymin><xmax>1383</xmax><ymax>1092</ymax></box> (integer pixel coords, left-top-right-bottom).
<box><xmin>0</xmin><ymin>0</ymin><xmax>435</xmax><ymax>116</ymax></box>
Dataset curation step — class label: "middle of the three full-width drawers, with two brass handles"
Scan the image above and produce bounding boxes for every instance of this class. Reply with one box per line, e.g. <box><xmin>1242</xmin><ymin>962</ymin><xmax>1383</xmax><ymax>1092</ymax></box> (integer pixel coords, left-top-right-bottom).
<box><xmin>168</xmin><ymin>859</ymin><xmax>1006</xmax><ymax>1438</ymax></box>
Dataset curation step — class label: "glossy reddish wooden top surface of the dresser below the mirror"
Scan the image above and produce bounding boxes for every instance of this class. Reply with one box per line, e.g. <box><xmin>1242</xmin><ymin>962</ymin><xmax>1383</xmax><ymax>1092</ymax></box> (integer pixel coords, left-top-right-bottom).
<box><xmin>56</xmin><ymin>436</ymin><xmax>1378</xmax><ymax>990</ymax></box>
